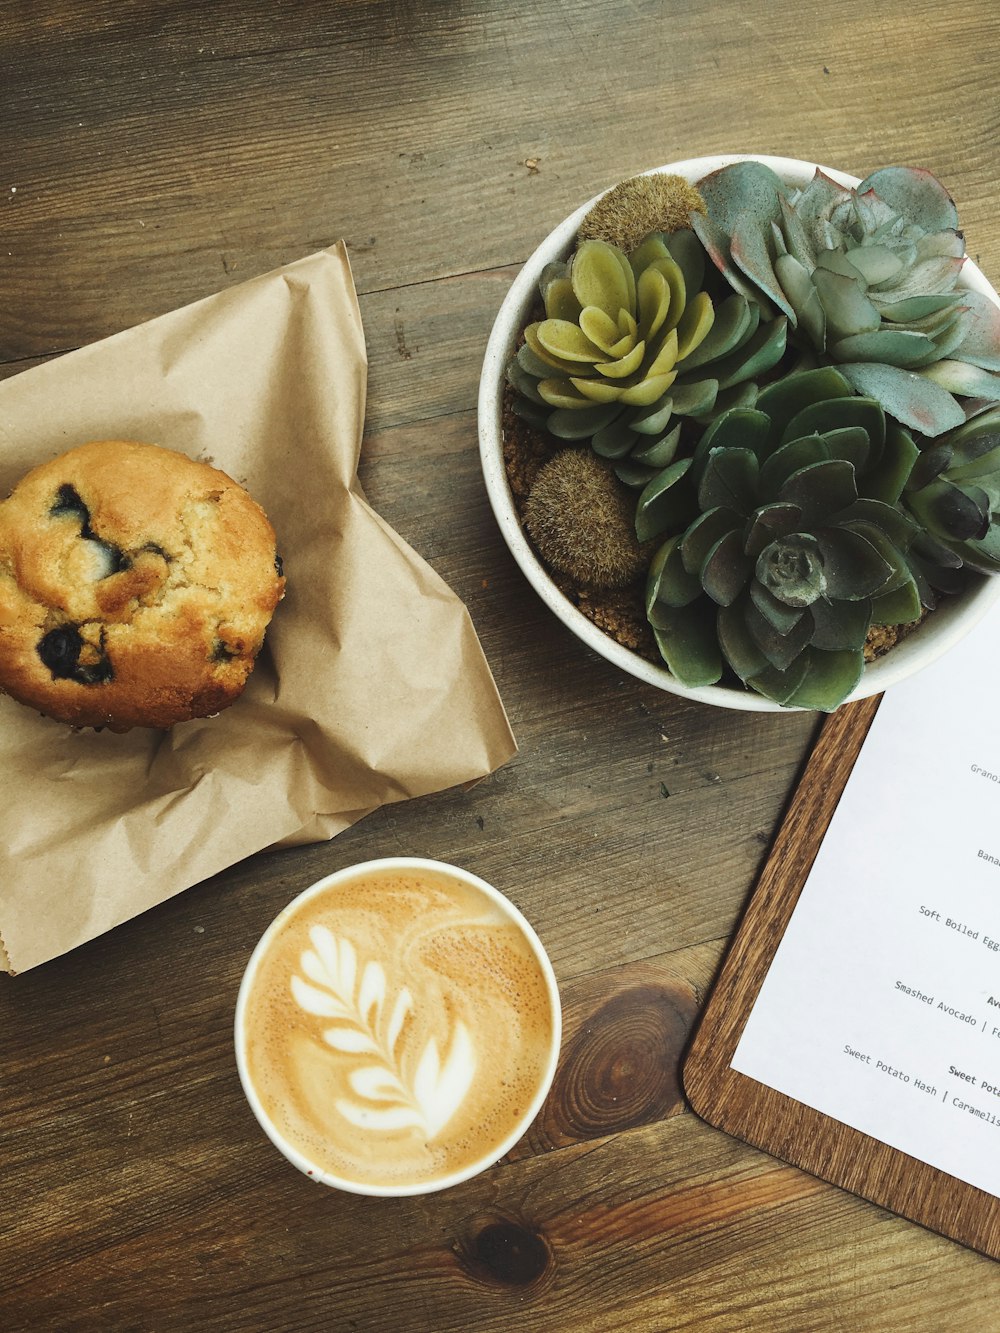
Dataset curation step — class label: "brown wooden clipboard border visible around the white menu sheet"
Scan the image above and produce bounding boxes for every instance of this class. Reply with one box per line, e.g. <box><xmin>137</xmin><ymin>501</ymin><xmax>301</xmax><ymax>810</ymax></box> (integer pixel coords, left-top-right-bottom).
<box><xmin>683</xmin><ymin>696</ymin><xmax>1000</xmax><ymax>1258</ymax></box>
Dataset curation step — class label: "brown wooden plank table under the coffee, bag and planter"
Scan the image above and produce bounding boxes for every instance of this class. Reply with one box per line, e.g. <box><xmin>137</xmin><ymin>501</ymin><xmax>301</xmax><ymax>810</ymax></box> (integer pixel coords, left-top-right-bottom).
<box><xmin>0</xmin><ymin>0</ymin><xmax>1000</xmax><ymax>1333</ymax></box>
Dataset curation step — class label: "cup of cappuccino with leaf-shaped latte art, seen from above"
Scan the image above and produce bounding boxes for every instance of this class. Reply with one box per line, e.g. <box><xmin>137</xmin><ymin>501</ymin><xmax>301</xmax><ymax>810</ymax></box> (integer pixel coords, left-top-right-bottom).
<box><xmin>236</xmin><ymin>858</ymin><xmax>560</xmax><ymax>1194</ymax></box>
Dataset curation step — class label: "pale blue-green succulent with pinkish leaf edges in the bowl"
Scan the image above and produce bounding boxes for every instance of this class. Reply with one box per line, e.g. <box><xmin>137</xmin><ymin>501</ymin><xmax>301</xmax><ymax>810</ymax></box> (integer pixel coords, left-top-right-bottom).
<box><xmin>691</xmin><ymin>161</ymin><xmax>1000</xmax><ymax>436</ymax></box>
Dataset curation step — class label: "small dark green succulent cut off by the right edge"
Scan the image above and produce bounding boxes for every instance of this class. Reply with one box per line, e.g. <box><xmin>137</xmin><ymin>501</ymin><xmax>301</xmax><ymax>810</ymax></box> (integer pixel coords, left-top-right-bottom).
<box><xmin>903</xmin><ymin>407</ymin><xmax>1000</xmax><ymax>575</ymax></box>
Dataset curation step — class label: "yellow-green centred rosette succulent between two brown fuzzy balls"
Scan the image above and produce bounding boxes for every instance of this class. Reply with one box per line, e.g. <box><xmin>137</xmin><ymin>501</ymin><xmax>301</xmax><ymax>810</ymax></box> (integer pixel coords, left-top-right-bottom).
<box><xmin>507</xmin><ymin>229</ymin><xmax>787</xmax><ymax>487</ymax></box>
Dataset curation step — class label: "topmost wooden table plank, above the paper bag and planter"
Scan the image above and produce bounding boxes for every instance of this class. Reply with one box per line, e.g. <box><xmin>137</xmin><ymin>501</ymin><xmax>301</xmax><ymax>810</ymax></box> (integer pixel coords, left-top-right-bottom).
<box><xmin>0</xmin><ymin>0</ymin><xmax>1000</xmax><ymax>360</ymax></box>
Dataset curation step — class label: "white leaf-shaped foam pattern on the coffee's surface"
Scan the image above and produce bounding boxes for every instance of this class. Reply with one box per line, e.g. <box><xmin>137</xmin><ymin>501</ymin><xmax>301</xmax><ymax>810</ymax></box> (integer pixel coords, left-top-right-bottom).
<box><xmin>292</xmin><ymin>925</ymin><xmax>476</xmax><ymax>1140</ymax></box>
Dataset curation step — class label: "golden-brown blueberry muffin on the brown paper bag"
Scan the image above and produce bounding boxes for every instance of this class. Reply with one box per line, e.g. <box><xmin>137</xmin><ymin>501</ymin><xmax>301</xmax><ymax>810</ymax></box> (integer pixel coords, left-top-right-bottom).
<box><xmin>0</xmin><ymin>440</ymin><xmax>284</xmax><ymax>732</ymax></box>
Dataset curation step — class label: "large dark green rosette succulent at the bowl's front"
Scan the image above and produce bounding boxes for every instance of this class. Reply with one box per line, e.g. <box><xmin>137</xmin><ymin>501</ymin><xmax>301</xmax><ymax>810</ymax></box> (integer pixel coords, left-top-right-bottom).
<box><xmin>637</xmin><ymin>367</ymin><xmax>933</xmax><ymax>710</ymax></box>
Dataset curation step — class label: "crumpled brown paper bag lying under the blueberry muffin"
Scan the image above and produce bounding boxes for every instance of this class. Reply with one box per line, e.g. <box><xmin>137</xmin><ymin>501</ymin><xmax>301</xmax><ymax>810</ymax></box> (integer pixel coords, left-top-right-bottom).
<box><xmin>0</xmin><ymin>245</ymin><xmax>515</xmax><ymax>972</ymax></box>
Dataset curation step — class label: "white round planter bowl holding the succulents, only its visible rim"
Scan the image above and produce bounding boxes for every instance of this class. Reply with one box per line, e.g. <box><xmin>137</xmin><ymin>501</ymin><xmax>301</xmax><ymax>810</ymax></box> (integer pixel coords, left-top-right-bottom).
<box><xmin>479</xmin><ymin>153</ymin><xmax>1000</xmax><ymax>712</ymax></box>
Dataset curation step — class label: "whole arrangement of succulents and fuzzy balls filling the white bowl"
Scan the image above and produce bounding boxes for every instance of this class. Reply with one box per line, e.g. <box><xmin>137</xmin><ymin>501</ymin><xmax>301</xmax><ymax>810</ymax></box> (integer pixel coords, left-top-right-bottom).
<box><xmin>507</xmin><ymin>161</ymin><xmax>1000</xmax><ymax>710</ymax></box>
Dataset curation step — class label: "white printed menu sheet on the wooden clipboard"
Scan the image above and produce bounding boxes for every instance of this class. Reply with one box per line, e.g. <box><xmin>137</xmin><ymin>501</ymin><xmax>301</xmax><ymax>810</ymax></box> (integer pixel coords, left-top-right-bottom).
<box><xmin>732</xmin><ymin>607</ymin><xmax>1000</xmax><ymax>1197</ymax></box>
